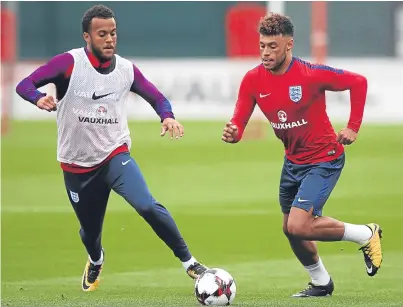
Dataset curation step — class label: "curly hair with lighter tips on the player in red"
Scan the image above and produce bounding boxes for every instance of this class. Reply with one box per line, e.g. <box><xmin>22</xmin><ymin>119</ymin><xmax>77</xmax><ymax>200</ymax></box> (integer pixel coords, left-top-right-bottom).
<box><xmin>258</xmin><ymin>13</ymin><xmax>294</xmax><ymax>37</ymax></box>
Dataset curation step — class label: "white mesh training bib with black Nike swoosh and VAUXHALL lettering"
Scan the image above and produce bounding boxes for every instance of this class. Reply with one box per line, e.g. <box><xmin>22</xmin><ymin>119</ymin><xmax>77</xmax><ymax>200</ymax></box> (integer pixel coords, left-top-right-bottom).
<box><xmin>57</xmin><ymin>48</ymin><xmax>134</xmax><ymax>167</ymax></box>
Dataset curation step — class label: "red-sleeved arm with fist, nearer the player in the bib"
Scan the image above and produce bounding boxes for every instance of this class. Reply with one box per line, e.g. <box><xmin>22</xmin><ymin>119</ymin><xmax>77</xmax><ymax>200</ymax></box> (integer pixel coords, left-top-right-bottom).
<box><xmin>221</xmin><ymin>71</ymin><xmax>256</xmax><ymax>143</ymax></box>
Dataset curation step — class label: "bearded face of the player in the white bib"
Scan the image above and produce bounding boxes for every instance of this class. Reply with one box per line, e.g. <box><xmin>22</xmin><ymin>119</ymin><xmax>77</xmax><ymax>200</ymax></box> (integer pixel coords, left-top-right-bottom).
<box><xmin>84</xmin><ymin>18</ymin><xmax>117</xmax><ymax>61</ymax></box>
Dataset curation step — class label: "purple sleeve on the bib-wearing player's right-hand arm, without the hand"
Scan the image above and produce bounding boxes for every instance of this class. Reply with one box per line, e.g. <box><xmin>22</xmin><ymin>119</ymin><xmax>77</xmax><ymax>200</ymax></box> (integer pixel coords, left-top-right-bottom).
<box><xmin>130</xmin><ymin>65</ymin><xmax>175</xmax><ymax>122</ymax></box>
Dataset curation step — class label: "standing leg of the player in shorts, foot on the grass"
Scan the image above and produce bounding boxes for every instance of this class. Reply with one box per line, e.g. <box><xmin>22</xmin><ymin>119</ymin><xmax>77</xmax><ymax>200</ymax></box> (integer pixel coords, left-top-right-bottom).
<box><xmin>279</xmin><ymin>159</ymin><xmax>334</xmax><ymax>297</ymax></box>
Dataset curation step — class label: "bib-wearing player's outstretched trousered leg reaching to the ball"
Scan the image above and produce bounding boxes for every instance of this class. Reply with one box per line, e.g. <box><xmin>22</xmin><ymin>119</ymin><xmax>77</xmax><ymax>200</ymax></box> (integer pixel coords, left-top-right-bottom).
<box><xmin>107</xmin><ymin>153</ymin><xmax>206</xmax><ymax>278</ymax></box>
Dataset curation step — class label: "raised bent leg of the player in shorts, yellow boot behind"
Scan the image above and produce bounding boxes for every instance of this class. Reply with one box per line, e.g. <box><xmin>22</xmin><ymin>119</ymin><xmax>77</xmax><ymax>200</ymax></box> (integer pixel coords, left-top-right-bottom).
<box><xmin>287</xmin><ymin>155</ymin><xmax>382</xmax><ymax>276</ymax></box>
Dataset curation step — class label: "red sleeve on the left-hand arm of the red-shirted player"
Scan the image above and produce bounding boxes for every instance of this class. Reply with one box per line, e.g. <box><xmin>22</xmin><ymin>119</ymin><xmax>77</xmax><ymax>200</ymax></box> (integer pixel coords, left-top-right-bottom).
<box><xmin>231</xmin><ymin>71</ymin><xmax>256</xmax><ymax>142</ymax></box>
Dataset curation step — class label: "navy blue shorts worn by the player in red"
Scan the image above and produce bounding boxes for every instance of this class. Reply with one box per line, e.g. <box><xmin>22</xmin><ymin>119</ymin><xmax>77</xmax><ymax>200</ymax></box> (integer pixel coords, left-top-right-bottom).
<box><xmin>279</xmin><ymin>153</ymin><xmax>345</xmax><ymax>216</ymax></box>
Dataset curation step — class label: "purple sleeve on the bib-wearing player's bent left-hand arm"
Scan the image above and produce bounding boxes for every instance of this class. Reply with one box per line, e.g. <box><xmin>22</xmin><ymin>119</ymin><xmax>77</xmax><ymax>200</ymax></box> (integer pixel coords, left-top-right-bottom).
<box><xmin>16</xmin><ymin>53</ymin><xmax>74</xmax><ymax>104</ymax></box>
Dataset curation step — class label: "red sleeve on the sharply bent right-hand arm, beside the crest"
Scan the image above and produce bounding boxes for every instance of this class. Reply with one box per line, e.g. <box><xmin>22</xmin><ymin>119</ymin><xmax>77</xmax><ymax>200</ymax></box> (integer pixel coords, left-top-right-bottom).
<box><xmin>314</xmin><ymin>65</ymin><xmax>368</xmax><ymax>132</ymax></box>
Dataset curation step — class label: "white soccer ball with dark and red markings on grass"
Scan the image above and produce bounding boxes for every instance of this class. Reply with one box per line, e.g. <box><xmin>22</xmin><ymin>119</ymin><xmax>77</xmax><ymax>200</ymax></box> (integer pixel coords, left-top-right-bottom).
<box><xmin>195</xmin><ymin>268</ymin><xmax>236</xmax><ymax>306</ymax></box>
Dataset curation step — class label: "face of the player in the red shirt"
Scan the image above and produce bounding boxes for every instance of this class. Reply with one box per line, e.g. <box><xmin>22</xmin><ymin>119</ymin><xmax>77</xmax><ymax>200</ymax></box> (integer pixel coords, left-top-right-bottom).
<box><xmin>260</xmin><ymin>35</ymin><xmax>294</xmax><ymax>71</ymax></box>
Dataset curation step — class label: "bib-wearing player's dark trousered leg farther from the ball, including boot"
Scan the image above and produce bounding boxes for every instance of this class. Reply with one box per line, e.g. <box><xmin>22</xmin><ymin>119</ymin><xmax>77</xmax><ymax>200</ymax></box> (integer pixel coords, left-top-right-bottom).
<box><xmin>64</xmin><ymin>169</ymin><xmax>111</xmax><ymax>291</ymax></box>
